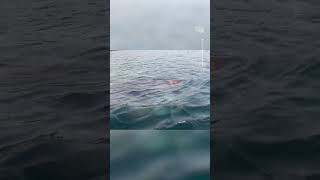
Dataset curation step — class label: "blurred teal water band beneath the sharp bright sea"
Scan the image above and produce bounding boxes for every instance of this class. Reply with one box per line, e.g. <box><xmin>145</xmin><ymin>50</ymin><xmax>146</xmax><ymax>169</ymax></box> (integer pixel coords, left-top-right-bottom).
<box><xmin>110</xmin><ymin>130</ymin><xmax>210</xmax><ymax>180</ymax></box>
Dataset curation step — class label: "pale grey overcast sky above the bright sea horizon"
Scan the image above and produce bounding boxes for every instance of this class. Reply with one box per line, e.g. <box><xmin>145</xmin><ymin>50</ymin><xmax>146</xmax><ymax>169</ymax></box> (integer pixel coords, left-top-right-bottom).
<box><xmin>110</xmin><ymin>0</ymin><xmax>210</xmax><ymax>50</ymax></box>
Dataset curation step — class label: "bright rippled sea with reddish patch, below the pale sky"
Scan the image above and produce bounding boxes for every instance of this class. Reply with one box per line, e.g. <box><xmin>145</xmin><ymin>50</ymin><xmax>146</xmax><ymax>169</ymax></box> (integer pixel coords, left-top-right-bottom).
<box><xmin>110</xmin><ymin>50</ymin><xmax>210</xmax><ymax>129</ymax></box>
